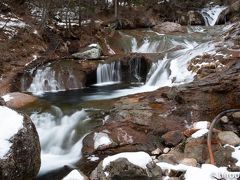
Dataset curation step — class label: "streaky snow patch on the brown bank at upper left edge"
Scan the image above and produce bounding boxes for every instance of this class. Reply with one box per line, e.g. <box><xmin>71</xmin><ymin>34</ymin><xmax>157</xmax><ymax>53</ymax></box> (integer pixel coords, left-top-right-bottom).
<box><xmin>0</xmin><ymin>14</ymin><xmax>26</xmax><ymax>39</ymax></box>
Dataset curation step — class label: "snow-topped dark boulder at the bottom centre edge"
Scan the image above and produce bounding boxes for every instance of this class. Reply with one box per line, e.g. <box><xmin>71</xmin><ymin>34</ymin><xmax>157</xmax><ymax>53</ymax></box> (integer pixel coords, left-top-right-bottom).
<box><xmin>91</xmin><ymin>152</ymin><xmax>161</xmax><ymax>180</ymax></box>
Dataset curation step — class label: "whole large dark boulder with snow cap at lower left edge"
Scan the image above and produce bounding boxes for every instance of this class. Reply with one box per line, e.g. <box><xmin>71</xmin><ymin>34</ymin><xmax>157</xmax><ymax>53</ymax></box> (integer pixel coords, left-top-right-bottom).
<box><xmin>0</xmin><ymin>106</ymin><xmax>41</xmax><ymax>180</ymax></box>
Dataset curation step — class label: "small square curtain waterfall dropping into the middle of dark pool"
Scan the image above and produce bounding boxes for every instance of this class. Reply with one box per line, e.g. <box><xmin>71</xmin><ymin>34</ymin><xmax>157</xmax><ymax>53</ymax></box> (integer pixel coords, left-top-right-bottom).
<box><xmin>97</xmin><ymin>61</ymin><xmax>121</xmax><ymax>85</ymax></box>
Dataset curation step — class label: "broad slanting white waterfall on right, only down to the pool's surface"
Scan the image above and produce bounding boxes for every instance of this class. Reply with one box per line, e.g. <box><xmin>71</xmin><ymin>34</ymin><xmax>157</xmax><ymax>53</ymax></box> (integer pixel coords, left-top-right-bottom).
<box><xmin>146</xmin><ymin>42</ymin><xmax>214</xmax><ymax>88</ymax></box>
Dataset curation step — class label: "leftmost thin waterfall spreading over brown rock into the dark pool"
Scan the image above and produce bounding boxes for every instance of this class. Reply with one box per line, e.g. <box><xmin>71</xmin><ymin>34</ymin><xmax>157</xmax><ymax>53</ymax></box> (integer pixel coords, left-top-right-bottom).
<box><xmin>26</xmin><ymin>66</ymin><xmax>83</xmax><ymax>95</ymax></box>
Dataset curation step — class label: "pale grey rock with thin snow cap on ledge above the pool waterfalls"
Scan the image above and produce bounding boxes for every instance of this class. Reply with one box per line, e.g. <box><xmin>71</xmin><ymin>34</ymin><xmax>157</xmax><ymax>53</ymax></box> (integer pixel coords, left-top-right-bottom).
<box><xmin>72</xmin><ymin>44</ymin><xmax>102</xmax><ymax>59</ymax></box>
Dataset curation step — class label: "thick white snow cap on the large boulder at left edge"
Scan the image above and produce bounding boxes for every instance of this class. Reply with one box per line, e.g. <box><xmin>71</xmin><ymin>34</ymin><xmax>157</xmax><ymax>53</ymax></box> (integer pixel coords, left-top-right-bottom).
<box><xmin>0</xmin><ymin>106</ymin><xmax>23</xmax><ymax>159</ymax></box>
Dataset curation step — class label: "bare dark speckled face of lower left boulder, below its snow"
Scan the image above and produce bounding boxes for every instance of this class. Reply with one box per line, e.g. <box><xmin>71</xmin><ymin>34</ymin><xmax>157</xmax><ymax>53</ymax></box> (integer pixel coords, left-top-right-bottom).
<box><xmin>0</xmin><ymin>112</ymin><xmax>41</xmax><ymax>180</ymax></box>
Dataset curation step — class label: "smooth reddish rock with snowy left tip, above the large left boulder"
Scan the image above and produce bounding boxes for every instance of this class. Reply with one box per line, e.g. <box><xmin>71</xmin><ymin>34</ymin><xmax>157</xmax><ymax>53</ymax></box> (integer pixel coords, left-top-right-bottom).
<box><xmin>2</xmin><ymin>92</ymin><xmax>37</xmax><ymax>109</ymax></box>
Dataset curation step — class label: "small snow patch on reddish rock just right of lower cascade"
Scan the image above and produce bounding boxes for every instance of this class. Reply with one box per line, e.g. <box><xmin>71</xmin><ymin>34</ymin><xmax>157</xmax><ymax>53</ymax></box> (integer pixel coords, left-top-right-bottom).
<box><xmin>93</xmin><ymin>132</ymin><xmax>112</xmax><ymax>149</ymax></box>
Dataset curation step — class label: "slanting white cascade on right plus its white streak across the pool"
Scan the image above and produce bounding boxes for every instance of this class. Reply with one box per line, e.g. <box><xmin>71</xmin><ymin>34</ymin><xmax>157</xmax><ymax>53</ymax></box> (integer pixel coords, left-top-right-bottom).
<box><xmin>85</xmin><ymin>42</ymin><xmax>215</xmax><ymax>100</ymax></box>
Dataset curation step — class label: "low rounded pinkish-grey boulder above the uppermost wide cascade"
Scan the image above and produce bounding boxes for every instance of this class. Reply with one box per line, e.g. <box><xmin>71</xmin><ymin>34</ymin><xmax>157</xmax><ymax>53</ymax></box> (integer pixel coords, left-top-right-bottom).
<box><xmin>153</xmin><ymin>22</ymin><xmax>185</xmax><ymax>34</ymax></box>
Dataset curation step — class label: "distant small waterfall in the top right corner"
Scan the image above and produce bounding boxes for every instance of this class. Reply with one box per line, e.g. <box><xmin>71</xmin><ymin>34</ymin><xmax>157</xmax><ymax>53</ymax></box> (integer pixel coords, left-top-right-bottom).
<box><xmin>200</xmin><ymin>5</ymin><xmax>227</xmax><ymax>26</ymax></box>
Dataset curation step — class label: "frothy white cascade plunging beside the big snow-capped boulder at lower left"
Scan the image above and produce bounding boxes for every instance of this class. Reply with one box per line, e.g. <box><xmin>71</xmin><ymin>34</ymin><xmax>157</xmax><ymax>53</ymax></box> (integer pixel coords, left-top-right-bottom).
<box><xmin>31</xmin><ymin>107</ymin><xmax>88</xmax><ymax>175</ymax></box>
